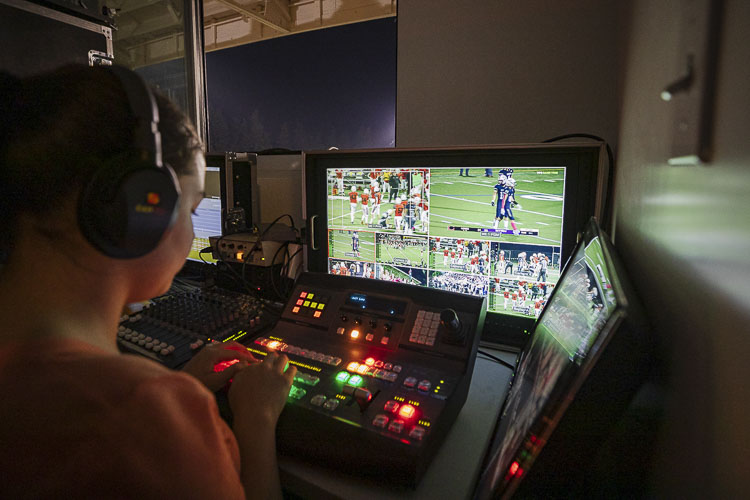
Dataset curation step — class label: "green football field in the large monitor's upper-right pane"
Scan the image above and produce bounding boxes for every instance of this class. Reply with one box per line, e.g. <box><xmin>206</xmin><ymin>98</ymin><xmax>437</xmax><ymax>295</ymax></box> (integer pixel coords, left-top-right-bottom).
<box><xmin>430</xmin><ymin>167</ymin><xmax>565</xmax><ymax>245</ymax></box>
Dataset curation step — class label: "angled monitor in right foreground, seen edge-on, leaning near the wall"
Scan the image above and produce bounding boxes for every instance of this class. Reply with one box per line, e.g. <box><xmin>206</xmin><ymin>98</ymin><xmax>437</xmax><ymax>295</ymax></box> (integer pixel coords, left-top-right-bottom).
<box><xmin>476</xmin><ymin>220</ymin><xmax>654</xmax><ymax>499</ymax></box>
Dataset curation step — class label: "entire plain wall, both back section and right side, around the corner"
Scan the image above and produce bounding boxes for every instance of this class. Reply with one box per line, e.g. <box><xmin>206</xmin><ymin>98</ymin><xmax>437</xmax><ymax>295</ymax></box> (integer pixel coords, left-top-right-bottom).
<box><xmin>406</xmin><ymin>0</ymin><xmax>750</xmax><ymax>498</ymax></box>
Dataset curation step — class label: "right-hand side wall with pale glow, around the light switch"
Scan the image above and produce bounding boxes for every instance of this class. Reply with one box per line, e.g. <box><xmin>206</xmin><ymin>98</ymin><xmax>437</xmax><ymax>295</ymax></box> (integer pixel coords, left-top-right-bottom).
<box><xmin>615</xmin><ymin>0</ymin><xmax>750</xmax><ymax>498</ymax></box>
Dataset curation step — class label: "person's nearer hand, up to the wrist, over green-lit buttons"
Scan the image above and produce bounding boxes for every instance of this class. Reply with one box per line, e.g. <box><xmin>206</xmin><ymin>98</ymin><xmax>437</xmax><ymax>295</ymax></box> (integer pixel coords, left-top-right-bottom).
<box><xmin>229</xmin><ymin>352</ymin><xmax>297</xmax><ymax>427</ymax></box>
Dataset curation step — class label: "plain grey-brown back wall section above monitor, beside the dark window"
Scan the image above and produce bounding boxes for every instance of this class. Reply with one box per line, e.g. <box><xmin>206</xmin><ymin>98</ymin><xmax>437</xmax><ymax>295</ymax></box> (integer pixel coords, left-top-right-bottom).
<box><xmin>396</xmin><ymin>0</ymin><xmax>627</xmax><ymax>147</ymax></box>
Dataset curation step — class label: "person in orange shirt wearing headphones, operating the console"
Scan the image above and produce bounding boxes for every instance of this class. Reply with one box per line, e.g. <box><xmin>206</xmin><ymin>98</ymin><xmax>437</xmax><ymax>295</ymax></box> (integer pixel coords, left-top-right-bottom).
<box><xmin>0</xmin><ymin>66</ymin><xmax>296</xmax><ymax>499</ymax></box>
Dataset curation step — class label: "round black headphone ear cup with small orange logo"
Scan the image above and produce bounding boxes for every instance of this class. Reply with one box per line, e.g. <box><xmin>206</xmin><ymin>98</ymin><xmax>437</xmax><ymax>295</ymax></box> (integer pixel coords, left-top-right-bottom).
<box><xmin>78</xmin><ymin>158</ymin><xmax>180</xmax><ymax>259</ymax></box>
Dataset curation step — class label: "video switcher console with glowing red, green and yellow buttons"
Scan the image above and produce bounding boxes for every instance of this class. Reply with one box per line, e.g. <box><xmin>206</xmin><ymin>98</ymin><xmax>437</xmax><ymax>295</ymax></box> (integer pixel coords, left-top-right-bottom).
<box><xmin>248</xmin><ymin>273</ymin><xmax>485</xmax><ymax>487</ymax></box>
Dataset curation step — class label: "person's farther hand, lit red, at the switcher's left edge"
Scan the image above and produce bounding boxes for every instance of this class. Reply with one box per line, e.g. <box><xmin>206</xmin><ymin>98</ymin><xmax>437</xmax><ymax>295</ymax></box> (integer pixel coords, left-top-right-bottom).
<box><xmin>182</xmin><ymin>342</ymin><xmax>258</xmax><ymax>392</ymax></box>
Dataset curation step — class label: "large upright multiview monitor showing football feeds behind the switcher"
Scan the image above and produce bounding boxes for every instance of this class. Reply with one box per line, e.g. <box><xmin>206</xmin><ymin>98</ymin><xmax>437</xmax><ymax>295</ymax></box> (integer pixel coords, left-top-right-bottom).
<box><xmin>305</xmin><ymin>143</ymin><xmax>606</xmax><ymax>347</ymax></box>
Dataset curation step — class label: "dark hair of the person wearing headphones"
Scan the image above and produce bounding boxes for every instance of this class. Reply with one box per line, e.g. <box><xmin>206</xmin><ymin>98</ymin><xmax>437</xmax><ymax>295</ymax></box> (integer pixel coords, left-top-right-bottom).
<box><xmin>0</xmin><ymin>65</ymin><xmax>202</xmax><ymax>254</ymax></box>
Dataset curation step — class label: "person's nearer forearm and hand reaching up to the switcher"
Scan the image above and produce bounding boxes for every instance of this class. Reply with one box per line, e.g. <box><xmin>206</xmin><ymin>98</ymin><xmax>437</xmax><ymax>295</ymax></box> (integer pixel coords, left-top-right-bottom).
<box><xmin>229</xmin><ymin>353</ymin><xmax>297</xmax><ymax>499</ymax></box>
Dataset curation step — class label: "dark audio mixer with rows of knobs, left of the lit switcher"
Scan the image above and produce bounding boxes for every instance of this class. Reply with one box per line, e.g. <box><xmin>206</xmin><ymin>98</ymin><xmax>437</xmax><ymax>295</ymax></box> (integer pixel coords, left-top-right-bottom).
<box><xmin>117</xmin><ymin>288</ymin><xmax>272</xmax><ymax>368</ymax></box>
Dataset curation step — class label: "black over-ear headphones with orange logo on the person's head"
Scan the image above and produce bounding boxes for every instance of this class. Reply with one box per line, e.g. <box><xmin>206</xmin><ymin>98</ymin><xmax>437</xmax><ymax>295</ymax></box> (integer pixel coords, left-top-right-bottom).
<box><xmin>78</xmin><ymin>66</ymin><xmax>180</xmax><ymax>259</ymax></box>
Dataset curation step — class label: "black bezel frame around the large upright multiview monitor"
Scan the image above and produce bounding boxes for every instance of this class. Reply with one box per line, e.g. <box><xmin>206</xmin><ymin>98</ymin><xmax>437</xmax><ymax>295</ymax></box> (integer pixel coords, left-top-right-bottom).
<box><xmin>303</xmin><ymin>142</ymin><xmax>607</xmax><ymax>349</ymax></box>
